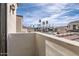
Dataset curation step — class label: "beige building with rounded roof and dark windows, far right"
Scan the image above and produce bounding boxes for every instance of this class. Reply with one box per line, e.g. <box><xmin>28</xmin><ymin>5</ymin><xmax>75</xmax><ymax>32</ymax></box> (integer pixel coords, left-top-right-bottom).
<box><xmin>56</xmin><ymin>21</ymin><xmax>79</xmax><ymax>33</ymax></box>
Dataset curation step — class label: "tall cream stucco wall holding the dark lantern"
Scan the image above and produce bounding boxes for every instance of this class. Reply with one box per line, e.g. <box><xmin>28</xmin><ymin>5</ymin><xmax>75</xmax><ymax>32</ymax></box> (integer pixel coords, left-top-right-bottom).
<box><xmin>7</xmin><ymin>3</ymin><xmax>17</xmax><ymax>33</ymax></box>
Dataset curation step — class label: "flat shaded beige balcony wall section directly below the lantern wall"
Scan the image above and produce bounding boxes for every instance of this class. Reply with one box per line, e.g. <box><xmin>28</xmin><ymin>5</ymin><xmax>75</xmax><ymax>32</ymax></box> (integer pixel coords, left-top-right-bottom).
<box><xmin>7</xmin><ymin>33</ymin><xmax>35</xmax><ymax>56</ymax></box>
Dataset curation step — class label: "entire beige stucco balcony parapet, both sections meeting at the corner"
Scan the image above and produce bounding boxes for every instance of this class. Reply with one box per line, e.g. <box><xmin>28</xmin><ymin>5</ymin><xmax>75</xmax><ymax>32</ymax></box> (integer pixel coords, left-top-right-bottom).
<box><xmin>7</xmin><ymin>32</ymin><xmax>79</xmax><ymax>56</ymax></box>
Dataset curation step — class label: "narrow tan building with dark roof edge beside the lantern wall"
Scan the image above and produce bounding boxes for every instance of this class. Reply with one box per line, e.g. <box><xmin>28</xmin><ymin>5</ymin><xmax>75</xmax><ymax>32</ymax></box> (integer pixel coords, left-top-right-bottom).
<box><xmin>16</xmin><ymin>15</ymin><xmax>23</xmax><ymax>32</ymax></box>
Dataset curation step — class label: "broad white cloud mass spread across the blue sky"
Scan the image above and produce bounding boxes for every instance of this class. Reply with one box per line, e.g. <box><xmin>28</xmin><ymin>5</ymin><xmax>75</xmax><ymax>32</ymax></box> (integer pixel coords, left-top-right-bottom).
<box><xmin>21</xmin><ymin>3</ymin><xmax>79</xmax><ymax>26</ymax></box>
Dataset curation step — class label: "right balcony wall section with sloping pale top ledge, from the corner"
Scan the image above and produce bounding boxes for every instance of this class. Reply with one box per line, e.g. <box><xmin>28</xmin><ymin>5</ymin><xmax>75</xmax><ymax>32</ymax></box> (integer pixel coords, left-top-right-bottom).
<box><xmin>36</xmin><ymin>33</ymin><xmax>79</xmax><ymax>56</ymax></box>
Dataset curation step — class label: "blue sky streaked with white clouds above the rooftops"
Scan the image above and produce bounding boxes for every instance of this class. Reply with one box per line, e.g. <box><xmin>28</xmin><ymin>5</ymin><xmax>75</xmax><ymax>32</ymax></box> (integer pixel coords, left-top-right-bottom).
<box><xmin>17</xmin><ymin>3</ymin><xmax>79</xmax><ymax>26</ymax></box>
